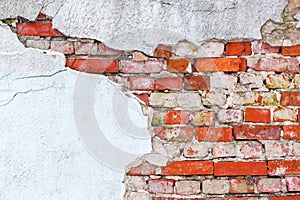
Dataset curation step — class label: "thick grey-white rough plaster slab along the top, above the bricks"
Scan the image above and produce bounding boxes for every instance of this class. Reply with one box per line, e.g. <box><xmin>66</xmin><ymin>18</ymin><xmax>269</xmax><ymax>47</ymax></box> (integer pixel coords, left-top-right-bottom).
<box><xmin>54</xmin><ymin>0</ymin><xmax>287</xmax><ymax>54</ymax></box>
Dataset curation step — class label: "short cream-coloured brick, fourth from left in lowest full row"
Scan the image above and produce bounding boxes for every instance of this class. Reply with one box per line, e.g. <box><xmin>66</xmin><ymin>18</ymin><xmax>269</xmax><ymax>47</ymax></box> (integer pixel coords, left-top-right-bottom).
<box><xmin>202</xmin><ymin>179</ymin><xmax>229</xmax><ymax>194</ymax></box>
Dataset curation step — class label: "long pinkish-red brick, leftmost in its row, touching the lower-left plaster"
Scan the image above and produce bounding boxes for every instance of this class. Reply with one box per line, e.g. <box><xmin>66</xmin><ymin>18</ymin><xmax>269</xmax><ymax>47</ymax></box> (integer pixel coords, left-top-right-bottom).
<box><xmin>66</xmin><ymin>58</ymin><xmax>118</xmax><ymax>73</ymax></box>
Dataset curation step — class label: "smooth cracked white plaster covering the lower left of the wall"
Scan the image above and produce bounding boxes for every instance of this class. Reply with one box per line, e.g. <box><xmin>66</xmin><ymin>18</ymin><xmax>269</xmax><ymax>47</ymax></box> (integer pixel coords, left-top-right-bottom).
<box><xmin>0</xmin><ymin>24</ymin><xmax>151</xmax><ymax>200</ymax></box>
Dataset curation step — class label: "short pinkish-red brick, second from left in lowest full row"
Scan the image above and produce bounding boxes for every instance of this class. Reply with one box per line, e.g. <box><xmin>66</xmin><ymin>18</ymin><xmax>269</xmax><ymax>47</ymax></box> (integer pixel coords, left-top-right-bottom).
<box><xmin>148</xmin><ymin>179</ymin><xmax>174</xmax><ymax>194</ymax></box>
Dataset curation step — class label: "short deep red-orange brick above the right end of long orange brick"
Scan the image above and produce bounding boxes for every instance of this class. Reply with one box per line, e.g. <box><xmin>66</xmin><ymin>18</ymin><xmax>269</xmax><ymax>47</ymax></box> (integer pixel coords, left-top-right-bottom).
<box><xmin>225</xmin><ymin>42</ymin><xmax>252</xmax><ymax>56</ymax></box>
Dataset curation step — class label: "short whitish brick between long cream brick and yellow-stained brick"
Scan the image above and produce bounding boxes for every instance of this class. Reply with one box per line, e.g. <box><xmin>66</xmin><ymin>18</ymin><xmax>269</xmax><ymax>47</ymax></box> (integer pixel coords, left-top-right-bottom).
<box><xmin>202</xmin><ymin>91</ymin><xmax>227</xmax><ymax>106</ymax></box>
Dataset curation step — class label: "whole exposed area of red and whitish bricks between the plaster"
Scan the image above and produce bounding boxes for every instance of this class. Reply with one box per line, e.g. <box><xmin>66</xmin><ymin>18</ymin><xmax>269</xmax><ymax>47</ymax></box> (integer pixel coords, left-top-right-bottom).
<box><xmin>12</xmin><ymin>14</ymin><xmax>300</xmax><ymax>200</ymax></box>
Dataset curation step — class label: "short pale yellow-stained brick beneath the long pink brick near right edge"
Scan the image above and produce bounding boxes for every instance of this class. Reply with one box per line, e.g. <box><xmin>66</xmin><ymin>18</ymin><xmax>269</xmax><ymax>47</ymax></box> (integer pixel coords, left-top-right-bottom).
<box><xmin>266</xmin><ymin>74</ymin><xmax>290</xmax><ymax>89</ymax></box>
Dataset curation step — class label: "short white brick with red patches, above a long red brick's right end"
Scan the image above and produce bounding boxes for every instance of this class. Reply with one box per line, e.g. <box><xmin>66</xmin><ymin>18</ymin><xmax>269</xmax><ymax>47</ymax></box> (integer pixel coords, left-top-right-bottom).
<box><xmin>183</xmin><ymin>142</ymin><xmax>209</xmax><ymax>158</ymax></box>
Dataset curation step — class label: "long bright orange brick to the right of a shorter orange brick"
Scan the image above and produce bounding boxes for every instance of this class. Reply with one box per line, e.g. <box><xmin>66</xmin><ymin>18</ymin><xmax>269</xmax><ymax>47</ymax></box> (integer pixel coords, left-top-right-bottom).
<box><xmin>194</xmin><ymin>58</ymin><xmax>247</xmax><ymax>72</ymax></box>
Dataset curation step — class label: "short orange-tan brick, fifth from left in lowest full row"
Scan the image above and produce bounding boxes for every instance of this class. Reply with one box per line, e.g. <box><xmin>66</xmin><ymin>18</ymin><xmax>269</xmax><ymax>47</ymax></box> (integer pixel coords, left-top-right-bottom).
<box><xmin>229</xmin><ymin>178</ymin><xmax>254</xmax><ymax>194</ymax></box>
